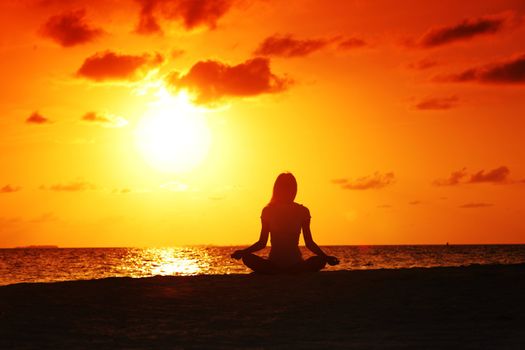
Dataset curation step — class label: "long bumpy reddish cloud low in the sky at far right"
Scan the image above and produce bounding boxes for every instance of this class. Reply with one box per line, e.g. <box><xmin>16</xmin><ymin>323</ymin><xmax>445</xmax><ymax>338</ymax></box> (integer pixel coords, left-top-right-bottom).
<box><xmin>434</xmin><ymin>166</ymin><xmax>510</xmax><ymax>186</ymax></box>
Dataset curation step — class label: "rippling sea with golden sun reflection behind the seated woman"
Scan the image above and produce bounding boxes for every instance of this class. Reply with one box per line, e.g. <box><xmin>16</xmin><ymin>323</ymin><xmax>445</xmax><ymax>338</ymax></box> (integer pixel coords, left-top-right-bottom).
<box><xmin>0</xmin><ymin>245</ymin><xmax>525</xmax><ymax>285</ymax></box>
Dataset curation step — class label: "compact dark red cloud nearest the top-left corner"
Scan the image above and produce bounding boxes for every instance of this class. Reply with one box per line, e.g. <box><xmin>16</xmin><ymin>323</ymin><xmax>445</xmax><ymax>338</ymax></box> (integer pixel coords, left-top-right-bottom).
<box><xmin>40</xmin><ymin>9</ymin><xmax>104</xmax><ymax>47</ymax></box>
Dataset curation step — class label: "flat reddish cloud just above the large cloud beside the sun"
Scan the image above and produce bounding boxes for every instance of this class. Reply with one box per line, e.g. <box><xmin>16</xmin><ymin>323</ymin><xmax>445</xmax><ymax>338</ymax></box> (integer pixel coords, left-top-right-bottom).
<box><xmin>254</xmin><ymin>34</ymin><xmax>330</xmax><ymax>57</ymax></box>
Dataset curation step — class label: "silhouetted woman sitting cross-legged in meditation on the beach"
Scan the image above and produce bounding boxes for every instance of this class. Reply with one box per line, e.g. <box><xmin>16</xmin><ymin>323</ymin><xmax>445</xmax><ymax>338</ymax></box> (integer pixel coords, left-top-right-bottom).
<box><xmin>231</xmin><ymin>173</ymin><xmax>339</xmax><ymax>274</ymax></box>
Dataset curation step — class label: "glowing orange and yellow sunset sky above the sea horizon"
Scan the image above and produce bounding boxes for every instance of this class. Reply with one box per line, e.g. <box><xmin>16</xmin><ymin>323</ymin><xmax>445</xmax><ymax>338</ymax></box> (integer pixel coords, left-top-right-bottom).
<box><xmin>0</xmin><ymin>0</ymin><xmax>525</xmax><ymax>247</ymax></box>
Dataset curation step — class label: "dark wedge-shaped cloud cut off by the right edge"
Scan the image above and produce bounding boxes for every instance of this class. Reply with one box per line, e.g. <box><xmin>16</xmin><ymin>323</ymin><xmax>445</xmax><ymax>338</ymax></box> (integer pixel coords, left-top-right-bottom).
<box><xmin>436</xmin><ymin>54</ymin><xmax>525</xmax><ymax>84</ymax></box>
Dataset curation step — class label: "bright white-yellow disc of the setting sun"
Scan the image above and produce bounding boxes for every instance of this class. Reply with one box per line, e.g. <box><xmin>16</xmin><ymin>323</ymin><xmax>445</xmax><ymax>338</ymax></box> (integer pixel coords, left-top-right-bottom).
<box><xmin>136</xmin><ymin>88</ymin><xmax>211</xmax><ymax>172</ymax></box>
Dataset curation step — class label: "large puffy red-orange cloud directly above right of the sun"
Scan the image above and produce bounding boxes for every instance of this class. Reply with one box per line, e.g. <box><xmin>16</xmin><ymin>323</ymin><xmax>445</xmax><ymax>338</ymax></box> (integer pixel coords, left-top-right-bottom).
<box><xmin>168</xmin><ymin>57</ymin><xmax>290</xmax><ymax>104</ymax></box>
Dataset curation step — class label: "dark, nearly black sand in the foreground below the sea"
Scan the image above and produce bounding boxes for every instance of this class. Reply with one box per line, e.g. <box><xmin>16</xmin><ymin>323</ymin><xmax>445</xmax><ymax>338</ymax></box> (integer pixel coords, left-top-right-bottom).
<box><xmin>0</xmin><ymin>264</ymin><xmax>525</xmax><ymax>349</ymax></box>
